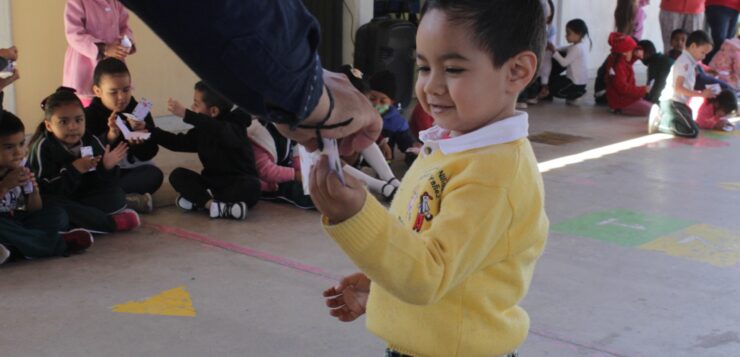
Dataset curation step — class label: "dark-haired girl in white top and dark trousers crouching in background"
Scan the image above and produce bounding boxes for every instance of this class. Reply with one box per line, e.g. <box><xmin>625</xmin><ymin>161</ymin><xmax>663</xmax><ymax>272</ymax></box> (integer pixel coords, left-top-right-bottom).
<box><xmin>547</xmin><ymin>19</ymin><xmax>593</xmax><ymax>105</ymax></box>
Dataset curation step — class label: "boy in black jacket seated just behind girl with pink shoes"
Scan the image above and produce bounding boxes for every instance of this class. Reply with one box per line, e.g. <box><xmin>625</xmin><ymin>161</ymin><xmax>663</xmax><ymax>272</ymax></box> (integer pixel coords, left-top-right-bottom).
<box><xmin>85</xmin><ymin>58</ymin><xmax>164</xmax><ymax>213</ymax></box>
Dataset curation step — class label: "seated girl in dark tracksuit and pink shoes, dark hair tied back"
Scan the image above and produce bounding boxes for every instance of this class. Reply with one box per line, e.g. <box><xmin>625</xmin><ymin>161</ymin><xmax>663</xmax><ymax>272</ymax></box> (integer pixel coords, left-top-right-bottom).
<box><xmin>29</xmin><ymin>87</ymin><xmax>141</xmax><ymax>233</ymax></box>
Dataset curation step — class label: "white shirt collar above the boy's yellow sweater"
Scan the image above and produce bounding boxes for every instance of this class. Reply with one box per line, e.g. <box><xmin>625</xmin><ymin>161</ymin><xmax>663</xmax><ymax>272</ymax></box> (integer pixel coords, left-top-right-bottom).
<box><xmin>419</xmin><ymin>111</ymin><xmax>529</xmax><ymax>155</ymax></box>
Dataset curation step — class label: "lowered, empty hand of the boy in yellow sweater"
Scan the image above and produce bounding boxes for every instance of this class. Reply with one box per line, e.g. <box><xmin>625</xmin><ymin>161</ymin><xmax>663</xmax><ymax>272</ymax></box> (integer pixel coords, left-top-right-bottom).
<box><xmin>324</xmin><ymin>273</ymin><xmax>370</xmax><ymax>322</ymax></box>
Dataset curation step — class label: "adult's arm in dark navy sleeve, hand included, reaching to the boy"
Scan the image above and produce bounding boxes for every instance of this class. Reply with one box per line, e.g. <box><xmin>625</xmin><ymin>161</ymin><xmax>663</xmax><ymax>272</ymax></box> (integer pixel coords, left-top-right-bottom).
<box><xmin>121</xmin><ymin>0</ymin><xmax>382</xmax><ymax>154</ymax></box>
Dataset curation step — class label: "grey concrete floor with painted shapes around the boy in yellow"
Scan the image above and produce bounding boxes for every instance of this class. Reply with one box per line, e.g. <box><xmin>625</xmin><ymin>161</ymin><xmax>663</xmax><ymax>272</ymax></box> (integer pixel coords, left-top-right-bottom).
<box><xmin>0</xmin><ymin>98</ymin><xmax>740</xmax><ymax>357</ymax></box>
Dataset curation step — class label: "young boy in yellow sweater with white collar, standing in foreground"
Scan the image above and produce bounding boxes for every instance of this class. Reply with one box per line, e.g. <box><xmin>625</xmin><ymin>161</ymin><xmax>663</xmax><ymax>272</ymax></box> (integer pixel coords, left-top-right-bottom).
<box><xmin>310</xmin><ymin>0</ymin><xmax>549</xmax><ymax>357</ymax></box>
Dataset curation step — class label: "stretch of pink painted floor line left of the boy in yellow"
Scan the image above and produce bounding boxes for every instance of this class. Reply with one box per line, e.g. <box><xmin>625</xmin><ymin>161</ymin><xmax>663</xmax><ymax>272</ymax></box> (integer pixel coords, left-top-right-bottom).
<box><xmin>145</xmin><ymin>224</ymin><xmax>341</xmax><ymax>281</ymax></box>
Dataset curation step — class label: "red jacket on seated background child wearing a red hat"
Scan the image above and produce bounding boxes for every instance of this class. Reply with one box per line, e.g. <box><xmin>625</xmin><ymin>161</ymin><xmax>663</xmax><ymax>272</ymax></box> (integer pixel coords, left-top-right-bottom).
<box><xmin>606</xmin><ymin>54</ymin><xmax>647</xmax><ymax>109</ymax></box>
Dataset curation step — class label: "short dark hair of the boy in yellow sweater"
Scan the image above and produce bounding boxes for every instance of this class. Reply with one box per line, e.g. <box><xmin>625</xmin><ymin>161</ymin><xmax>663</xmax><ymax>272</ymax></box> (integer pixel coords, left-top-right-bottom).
<box><xmin>422</xmin><ymin>0</ymin><xmax>545</xmax><ymax>68</ymax></box>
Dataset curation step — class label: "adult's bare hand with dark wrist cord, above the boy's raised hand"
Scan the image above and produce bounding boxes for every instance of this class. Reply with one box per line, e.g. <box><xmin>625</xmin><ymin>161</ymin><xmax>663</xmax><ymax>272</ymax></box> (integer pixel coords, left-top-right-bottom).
<box><xmin>276</xmin><ymin>70</ymin><xmax>383</xmax><ymax>155</ymax></box>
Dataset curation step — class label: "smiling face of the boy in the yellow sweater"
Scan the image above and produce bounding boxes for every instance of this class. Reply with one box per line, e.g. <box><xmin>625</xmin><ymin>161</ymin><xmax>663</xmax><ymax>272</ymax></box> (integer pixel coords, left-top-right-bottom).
<box><xmin>416</xmin><ymin>10</ymin><xmax>536</xmax><ymax>134</ymax></box>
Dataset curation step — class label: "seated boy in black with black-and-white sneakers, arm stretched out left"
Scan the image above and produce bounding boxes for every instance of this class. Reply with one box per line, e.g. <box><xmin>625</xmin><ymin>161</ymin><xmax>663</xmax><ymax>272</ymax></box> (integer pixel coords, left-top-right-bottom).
<box><xmin>151</xmin><ymin>81</ymin><xmax>260</xmax><ymax>219</ymax></box>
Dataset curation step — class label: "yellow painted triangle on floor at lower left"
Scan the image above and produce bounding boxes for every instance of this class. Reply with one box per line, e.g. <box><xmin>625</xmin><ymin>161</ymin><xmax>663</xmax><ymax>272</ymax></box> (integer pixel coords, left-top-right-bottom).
<box><xmin>113</xmin><ymin>285</ymin><xmax>197</xmax><ymax>317</ymax></box>
